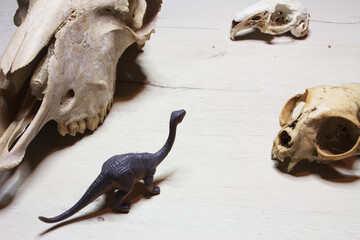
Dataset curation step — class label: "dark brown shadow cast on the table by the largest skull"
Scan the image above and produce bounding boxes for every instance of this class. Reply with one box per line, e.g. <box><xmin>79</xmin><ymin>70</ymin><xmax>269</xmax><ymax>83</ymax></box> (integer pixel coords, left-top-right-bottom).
<box><xmin>0</xmin><ymin>44</ymin><xmax>147</xmax><ymax>210</ymax></box>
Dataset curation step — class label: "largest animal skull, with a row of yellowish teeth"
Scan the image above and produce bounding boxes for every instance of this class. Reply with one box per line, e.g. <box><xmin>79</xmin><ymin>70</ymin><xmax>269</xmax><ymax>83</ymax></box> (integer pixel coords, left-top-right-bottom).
<box><xmin>0</xmin><ymin>0</ymin><xmax>161</xmax><ymax>170</ymax></box>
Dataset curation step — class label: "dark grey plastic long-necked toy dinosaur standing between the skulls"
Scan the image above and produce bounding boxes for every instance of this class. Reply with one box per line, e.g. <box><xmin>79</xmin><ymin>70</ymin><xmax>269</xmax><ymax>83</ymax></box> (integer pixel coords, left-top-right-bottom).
<box><xmin>39</xmin><ymin>110</ymin><xmax>186</xmax><ymax>223</ymax></box>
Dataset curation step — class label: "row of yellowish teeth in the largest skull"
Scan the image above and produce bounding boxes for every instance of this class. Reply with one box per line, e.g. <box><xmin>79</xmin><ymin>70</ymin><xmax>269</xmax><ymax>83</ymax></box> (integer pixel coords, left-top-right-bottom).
<box><xmin>57</xmin><ymin>100</ymin><xmax>112</xmax><ymax>136</ymax></box>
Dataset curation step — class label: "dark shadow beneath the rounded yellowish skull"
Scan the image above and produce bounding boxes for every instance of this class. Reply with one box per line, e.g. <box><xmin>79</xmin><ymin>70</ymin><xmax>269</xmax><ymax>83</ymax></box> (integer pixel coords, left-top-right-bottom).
<box><xmin>275</xmin><ymin>157</ymin><xmax>360</xmax><ymax>183</ymax></box>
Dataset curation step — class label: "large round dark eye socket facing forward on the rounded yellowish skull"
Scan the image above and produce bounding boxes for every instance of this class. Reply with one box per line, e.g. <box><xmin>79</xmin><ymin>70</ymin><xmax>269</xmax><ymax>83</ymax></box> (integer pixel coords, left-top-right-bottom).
<box><xmin>317</xmin><ymin>117</ymin><xmax>360</xmax><ymax>154</ymax></box>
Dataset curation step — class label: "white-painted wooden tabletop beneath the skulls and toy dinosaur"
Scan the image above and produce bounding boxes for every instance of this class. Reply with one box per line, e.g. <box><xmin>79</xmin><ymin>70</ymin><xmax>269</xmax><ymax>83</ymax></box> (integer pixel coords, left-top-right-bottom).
<box><xmin>0</xmin><ymin>0</ymin><xmax>360</xmax><ymax>240</ymax></box>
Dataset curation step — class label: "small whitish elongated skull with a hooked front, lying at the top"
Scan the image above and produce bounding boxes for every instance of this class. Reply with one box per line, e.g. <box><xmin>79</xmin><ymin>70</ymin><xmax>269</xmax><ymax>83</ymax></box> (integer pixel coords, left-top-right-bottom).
<box><xmin>230</xmin><ymin>0</ymin><xmax>310</xmax><ymax>40</ymax></box>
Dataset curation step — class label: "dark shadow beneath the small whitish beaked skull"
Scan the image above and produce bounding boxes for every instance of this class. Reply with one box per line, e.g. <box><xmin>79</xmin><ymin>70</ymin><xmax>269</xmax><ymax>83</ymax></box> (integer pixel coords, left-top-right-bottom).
<box><xmin>234</xmin><ymin>29</ymin><xmax>310</xmax><ymax>44</ymax></box>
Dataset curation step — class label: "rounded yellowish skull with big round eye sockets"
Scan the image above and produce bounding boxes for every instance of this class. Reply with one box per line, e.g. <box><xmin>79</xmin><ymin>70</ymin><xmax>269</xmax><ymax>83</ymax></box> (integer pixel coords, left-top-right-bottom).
<box><xmin>272</xmin><ymin>83</ymin><xmax>360</xmax><ymax>171</ymax></box>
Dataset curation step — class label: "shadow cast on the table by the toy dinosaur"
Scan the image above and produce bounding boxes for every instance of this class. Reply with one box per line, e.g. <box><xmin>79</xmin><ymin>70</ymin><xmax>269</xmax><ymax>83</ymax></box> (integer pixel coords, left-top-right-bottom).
<box><xmin>39</xmin><ymin>176</ymin><xmax>173</xmax><ymax>236</ymax></box>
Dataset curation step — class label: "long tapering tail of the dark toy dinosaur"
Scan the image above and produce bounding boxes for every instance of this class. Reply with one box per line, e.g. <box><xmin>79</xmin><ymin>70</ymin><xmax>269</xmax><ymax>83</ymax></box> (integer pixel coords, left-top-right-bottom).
<box><xmin>39</xmin><ymin>173</ymin><xmax>112</xmax><ymax>223</ymax></box>
